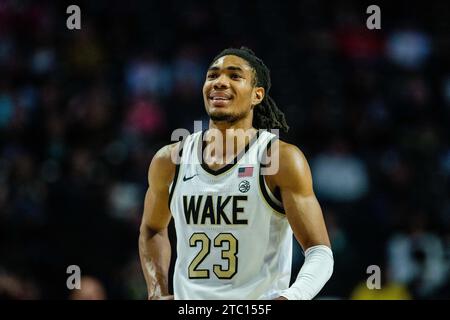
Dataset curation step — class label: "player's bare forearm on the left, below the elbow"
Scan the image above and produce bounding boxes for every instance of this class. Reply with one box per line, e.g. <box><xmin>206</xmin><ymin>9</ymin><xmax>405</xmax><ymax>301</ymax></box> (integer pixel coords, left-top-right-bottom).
<box><xmin>139</xmin><ymin>227</ymin><xmax>171</xmax><ymax>298</ymax></box>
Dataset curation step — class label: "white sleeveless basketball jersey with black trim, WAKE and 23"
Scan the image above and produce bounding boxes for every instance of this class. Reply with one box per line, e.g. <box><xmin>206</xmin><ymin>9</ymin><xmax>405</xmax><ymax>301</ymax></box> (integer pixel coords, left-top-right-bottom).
<box><xmin>169</xmin><ymin>130</ymin><xmax>292</xmax><ymax>300</ymax></box>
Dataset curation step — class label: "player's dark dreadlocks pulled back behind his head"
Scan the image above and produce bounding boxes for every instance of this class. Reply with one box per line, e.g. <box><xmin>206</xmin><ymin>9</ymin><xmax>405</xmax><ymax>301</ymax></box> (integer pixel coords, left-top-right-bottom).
<box><xmin>213</xmin><ymin>47</ymin><xmax>289</xmax><ymax>132</ymax></box>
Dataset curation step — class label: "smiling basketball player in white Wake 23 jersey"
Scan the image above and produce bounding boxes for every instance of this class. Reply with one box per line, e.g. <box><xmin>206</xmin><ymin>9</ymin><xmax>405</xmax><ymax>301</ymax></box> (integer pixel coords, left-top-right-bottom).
<box><xmin>139</xmin><ymin>47</ymin><xmax>333</xmax><ymax>300</ymax></box>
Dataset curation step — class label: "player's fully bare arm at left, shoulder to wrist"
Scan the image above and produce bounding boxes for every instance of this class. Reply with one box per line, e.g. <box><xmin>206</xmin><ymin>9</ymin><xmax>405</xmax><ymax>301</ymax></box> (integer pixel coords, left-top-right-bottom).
<box><xmin>139</xmin><ymin>143</ymin><xmax>179</xmax><ymax>299</ymax></box>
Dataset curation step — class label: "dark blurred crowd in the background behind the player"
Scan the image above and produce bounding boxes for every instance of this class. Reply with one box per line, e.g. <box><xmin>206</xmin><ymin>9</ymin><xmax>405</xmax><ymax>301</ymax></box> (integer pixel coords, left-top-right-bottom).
<box><xmin>0</xmin><ymin>0</ymin><xmax>450</xmax><ymax>299</ymax></box>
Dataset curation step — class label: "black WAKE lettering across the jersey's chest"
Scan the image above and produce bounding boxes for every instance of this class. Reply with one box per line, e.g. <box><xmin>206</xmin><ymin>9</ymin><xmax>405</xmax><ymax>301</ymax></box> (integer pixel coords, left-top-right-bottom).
<box><xmin>183</xmin><ymin>195</ymin><xmax>248</xmax><ymax>225</ymax></box>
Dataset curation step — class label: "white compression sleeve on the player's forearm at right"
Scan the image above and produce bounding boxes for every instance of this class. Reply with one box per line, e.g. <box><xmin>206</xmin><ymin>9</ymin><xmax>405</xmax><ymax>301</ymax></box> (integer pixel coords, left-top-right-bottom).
<box><xmin>280</xmin><ymin>245</ymin><xmax>334</xmax><ymax>300</ymax></box>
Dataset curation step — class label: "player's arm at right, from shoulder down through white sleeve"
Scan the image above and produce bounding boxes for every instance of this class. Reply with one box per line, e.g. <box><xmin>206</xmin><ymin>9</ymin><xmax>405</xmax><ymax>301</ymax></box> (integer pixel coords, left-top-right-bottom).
<box><xmin>266</xmin><ymin>141</ymin><xmax>333</xmax><ymax>298</ymax></box>
